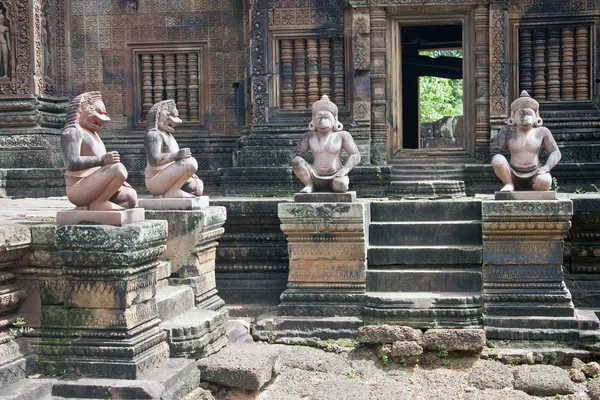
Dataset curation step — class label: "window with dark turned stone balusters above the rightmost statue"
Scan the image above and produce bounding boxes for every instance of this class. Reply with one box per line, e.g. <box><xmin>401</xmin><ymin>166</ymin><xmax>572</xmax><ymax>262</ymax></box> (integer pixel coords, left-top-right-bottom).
<box><xmin>515</xmin><ymin>23</ymin><xmax>592</xmax><ymax>101</ymax></box>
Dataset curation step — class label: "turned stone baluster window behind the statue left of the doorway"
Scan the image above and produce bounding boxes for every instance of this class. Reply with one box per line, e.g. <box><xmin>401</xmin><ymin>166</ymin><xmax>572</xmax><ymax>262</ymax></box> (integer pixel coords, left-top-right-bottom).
<box><xmin>272</xmin><ymin>35</ymin><xmax>346</xmax><ymax>111</ymax></box>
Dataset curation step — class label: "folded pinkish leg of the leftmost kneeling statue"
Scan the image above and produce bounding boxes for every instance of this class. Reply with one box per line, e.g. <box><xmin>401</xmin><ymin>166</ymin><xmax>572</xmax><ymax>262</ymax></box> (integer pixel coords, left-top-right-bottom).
<box><xmin>67</xmin><ymin>163</ymin><xmax>127</xmax><ymax>211</ymax></box>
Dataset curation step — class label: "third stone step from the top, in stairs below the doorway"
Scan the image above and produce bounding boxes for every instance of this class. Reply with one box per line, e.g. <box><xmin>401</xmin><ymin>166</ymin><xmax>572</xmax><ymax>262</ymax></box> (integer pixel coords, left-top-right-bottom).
<box><xmin>367</xmin><ymin>246</ymin><xmax>482</xmax><ymax>268</ymax></box>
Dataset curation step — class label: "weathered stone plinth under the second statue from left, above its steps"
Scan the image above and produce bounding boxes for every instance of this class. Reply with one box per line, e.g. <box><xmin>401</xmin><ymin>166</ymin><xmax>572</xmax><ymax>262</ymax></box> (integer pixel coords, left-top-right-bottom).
<box><xmin>146</xmin><ymin>207</ymin><xmax>227</xmax><ymax>310</ymax></box>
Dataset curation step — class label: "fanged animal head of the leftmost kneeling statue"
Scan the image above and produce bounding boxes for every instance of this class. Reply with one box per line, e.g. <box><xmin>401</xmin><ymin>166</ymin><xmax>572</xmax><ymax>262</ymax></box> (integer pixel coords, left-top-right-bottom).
<box><xmin>66</xmin><ymin>92</ymin><xmax>110</xmax><ymax>133</ymax></box>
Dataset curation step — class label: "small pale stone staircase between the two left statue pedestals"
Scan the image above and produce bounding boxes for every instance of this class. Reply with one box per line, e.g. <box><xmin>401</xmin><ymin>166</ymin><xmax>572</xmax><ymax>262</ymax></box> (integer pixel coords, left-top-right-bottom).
<box><xmin>155</xmin><ymin>261</ymin><xmax>228</xmax><ymax>359</ymax></box>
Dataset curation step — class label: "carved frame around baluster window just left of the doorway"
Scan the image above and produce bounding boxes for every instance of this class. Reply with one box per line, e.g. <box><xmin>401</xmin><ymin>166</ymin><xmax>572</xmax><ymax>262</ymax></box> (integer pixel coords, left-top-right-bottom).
<box><xmin>268</xmin><ymin>27</ymin><xmax>351</xmax><ymax>122</ymax></box>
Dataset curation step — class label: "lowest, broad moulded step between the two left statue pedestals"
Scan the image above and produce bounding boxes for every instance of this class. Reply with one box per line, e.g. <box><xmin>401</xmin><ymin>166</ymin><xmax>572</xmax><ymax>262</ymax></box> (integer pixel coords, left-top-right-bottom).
<box><xmin>160</xmin><ymin>308</ymin><xmax>228</xmax><ymax>359</ymax></box>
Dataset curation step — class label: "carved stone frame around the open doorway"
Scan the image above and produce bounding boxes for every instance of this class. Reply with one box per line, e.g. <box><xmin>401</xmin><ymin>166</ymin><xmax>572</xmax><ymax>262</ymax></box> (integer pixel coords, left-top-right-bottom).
<box><xmin>386</xmin><ymin>6</ymin><xmax>477</xmax><ymax>157</ymax></box>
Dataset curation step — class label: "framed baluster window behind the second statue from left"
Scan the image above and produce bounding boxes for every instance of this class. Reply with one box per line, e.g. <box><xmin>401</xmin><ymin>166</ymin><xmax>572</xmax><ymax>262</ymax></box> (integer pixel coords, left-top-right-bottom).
<box><xmin>128</xmin><ymin>43</ymin><xmax>209</xmax><ymax>127</ymax></box>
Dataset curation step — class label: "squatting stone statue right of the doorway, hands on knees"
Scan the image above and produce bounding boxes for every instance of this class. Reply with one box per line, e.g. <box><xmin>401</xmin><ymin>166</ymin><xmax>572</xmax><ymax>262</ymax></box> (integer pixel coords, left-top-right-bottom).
<box><xmin>492</xmin><ymin>91</ymin><xmax>561</xmax><ymax>192</ymax></box>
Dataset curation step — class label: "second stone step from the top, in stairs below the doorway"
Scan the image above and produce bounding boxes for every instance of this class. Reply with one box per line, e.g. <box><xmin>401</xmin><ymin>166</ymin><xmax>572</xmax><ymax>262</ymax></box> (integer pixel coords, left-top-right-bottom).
<box><xmin>369</xmin><ymin>221</ymin><xmax>481</xmax><ymax>246</ymax></box>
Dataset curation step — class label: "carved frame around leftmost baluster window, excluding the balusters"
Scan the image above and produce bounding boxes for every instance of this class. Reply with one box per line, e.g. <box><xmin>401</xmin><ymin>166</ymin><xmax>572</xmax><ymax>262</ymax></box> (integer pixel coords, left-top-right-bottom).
<box><xmin>126</xmin><ymin>42</ymin><xmax>211</xmax><ymax>131</ymax></box>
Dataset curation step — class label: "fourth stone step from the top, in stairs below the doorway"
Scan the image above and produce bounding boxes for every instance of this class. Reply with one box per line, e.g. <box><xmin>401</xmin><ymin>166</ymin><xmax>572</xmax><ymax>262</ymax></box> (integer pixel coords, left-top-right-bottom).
<box><xmin>367</xmin><ymin>268</ymin><xmax>481</xmax><ymax>292</ymax></box>
